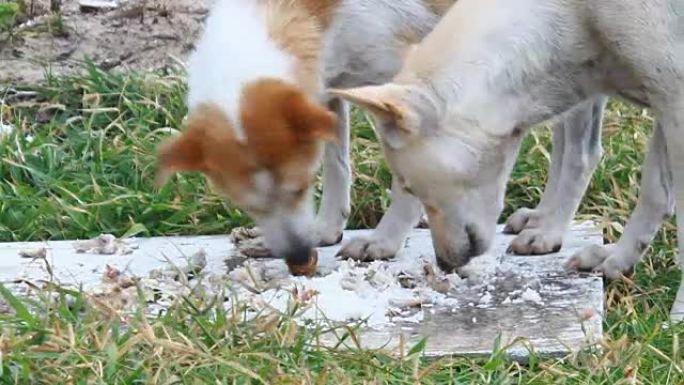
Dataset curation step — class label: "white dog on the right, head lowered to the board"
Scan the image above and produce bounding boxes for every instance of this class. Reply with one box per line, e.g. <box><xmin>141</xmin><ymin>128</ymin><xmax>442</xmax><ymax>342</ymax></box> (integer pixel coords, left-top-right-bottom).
<box><xmin>332</xmin><ymin>0</ymin><xmax>684</xmax><ymax>320</ymax></box>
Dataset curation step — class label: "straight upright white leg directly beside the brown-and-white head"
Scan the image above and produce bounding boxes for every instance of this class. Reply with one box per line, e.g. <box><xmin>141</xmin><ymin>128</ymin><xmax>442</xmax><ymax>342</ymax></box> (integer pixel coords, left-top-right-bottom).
<box><xmin>316</xmin><ymin>99</ymin><xmax>351</xmax><ymax>246</ymax></box>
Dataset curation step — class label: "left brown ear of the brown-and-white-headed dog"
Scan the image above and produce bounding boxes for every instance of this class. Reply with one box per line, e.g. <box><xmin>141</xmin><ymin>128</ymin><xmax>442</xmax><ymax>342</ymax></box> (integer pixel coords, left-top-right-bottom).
<box><xmin>156</xmin><ymin>130</ymin><xmax>206</xmax><ymax>187</ymax></box>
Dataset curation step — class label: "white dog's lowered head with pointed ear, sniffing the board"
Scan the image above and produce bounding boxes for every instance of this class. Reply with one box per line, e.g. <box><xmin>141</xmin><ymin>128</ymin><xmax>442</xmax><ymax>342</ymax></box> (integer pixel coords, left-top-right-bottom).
<box><xmin>330</xmin><ymin>83</ymin><xmax>519</xmax><ymax>271</ymax></box>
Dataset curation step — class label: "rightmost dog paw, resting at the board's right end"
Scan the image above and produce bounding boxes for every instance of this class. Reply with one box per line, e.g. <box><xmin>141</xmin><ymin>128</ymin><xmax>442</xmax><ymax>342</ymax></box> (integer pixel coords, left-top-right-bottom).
<box><xmin>565</xmin><ymin>245</ymin><xmax>638</xmax><ymax>279</ymax></box>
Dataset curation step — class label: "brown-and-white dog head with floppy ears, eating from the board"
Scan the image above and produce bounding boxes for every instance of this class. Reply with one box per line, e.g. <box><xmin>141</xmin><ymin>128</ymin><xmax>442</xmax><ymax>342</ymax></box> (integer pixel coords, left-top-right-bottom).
<box><xmin>158</xmin><ymin>80</ymin><xmax>337</xmax><ymax>265</ymax></box>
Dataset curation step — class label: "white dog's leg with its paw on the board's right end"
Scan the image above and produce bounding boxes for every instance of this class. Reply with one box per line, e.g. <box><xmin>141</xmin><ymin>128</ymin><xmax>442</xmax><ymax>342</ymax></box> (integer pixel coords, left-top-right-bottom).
<box><xmin>567</xmin><ymin>126</ymin><xmax>684</xmax><ymax>316</ymax></box>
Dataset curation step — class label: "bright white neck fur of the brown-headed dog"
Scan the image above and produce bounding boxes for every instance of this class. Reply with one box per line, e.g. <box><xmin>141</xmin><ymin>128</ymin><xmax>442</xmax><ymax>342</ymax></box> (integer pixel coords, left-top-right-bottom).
<box><xmin>188</xmin><ymin>0</ymin><xmax>294</xmax><ymax>139</ymax></box>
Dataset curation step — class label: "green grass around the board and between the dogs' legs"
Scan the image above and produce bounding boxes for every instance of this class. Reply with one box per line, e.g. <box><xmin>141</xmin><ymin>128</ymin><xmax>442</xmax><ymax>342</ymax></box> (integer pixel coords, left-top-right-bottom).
<box><xmin>0</xmin><ymin>66</ymin><xmax>684</xmax><ymax>385</ymax></box>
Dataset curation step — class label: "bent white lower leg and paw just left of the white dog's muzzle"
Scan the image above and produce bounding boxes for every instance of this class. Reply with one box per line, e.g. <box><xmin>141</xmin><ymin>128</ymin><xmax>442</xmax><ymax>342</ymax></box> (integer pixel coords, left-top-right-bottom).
<box><xmin>339</xmin><ymin>179</ymin><xmax>423</xmax><ymax>261</ymax></box>
